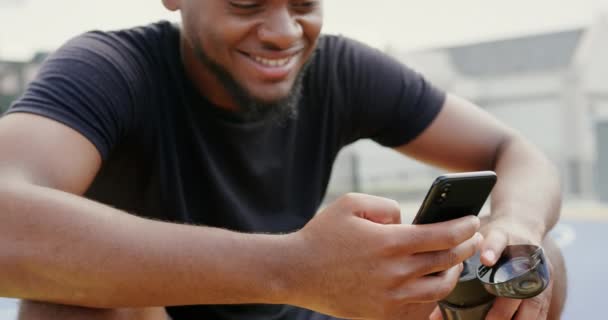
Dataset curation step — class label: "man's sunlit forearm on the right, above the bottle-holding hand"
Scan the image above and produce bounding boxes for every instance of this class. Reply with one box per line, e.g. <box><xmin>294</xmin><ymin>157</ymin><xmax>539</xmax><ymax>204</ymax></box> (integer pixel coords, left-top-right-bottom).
<box><xmin>492</xmin><ymin>136</ymin><xmax>561</xmax><ymax>237</ymax></box>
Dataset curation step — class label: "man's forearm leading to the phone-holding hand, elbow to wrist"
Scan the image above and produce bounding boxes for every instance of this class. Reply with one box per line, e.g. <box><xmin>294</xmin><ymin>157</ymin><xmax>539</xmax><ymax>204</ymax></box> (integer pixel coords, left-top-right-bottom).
<box><xmin>0</xmin><ymin>180</ymin><xmax>288</xmax><ymax>308</ymax></box>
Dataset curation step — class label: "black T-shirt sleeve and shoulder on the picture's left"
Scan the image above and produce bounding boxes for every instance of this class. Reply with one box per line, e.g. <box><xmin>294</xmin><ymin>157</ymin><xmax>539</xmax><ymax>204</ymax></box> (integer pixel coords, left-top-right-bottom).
<box><xmin>8</xmin><ymin>23</ymin><xmax>179</xmax><ymax>159</ymax></box>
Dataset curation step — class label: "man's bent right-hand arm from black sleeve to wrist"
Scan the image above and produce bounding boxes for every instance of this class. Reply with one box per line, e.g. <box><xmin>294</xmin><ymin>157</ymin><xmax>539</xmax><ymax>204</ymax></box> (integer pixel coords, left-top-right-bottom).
<box><xmin>397</xmin><ymin>95</ymin><xmax>561</xmax><ymax>245</ymax></box>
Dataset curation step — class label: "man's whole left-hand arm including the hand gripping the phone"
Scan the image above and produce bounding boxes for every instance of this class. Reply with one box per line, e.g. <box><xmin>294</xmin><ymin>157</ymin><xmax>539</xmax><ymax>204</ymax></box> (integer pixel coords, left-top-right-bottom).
<box><xmin>0</xmin><ymin>114</ymin><xmax>481</xmax><ymax>318</ymax></box>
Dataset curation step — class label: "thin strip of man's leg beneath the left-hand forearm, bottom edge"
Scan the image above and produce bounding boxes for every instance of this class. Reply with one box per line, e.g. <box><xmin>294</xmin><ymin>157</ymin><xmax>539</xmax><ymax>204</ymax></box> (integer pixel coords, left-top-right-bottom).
<box><xmin>18</xmin><ymin>301</ymin><xmax>169</xmax><ymax>320</ymax></box>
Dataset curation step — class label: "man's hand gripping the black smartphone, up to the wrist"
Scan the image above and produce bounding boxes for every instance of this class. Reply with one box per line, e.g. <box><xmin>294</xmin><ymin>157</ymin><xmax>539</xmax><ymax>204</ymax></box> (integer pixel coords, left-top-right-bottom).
<box><xmin>289</xmin><ymin>194</ymin><xmax>482</xmax><ymax>319</ymax></box>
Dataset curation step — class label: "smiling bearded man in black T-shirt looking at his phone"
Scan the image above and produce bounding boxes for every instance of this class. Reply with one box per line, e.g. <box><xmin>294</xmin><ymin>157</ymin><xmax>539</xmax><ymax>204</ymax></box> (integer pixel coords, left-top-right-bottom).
<box><xmin>0</xmin><ymin>0</ymin><xmax>564</xmax><ymax>320</ymax></box>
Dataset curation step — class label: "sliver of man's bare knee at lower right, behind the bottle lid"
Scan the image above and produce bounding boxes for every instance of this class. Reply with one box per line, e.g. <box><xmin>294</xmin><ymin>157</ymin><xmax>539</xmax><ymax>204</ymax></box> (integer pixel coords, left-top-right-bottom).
<box><xmin>543</xmin><ymin>237</ymin><xmax>568</xmax><ymax>320</ymax></box>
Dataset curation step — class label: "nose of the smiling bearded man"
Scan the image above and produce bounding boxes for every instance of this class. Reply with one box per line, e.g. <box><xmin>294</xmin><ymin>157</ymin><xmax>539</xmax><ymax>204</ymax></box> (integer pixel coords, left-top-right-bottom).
<box><xmin>258</xmin><ymin>8</ymin><xmax>303</xmax><ymax>50</ymax></box>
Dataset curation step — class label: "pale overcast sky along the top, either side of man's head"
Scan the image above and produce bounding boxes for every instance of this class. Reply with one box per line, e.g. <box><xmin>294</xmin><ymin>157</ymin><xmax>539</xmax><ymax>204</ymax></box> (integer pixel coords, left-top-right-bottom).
<box><xmin>0</xmin><ymin>0</ymin><xmax>608</xmax><ymax>60</ymax></box>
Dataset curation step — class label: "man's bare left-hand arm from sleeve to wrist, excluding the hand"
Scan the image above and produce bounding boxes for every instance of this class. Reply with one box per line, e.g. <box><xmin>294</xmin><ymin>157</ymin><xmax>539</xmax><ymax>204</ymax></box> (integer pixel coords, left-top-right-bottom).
<box><xmin>0</xmin><ymin>114</ymin><xmax>286</xmax><ymax>307</ymax></box>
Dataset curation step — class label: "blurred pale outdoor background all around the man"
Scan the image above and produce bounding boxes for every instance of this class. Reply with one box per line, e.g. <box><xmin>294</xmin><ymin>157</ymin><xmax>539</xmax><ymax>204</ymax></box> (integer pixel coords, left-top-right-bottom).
<box><xmin>0</xmin><ymin>0</ymin><xmax>608</xmax><ymax>320</ymax></box>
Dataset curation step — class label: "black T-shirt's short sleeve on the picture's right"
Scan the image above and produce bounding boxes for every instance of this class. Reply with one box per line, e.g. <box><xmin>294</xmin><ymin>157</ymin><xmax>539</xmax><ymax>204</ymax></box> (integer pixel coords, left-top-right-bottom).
<box><xmin>330</xmin><ymin>38</ymin><xmax>445</xmax><ymax>147</ymax></box>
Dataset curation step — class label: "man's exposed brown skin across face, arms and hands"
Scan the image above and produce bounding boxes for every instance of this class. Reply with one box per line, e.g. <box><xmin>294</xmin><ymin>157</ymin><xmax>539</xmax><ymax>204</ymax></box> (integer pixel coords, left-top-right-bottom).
<box><xmin>0</xmin><ymin>0</ymin><xmax>559</xmax><ymax>319</ymax></box>
